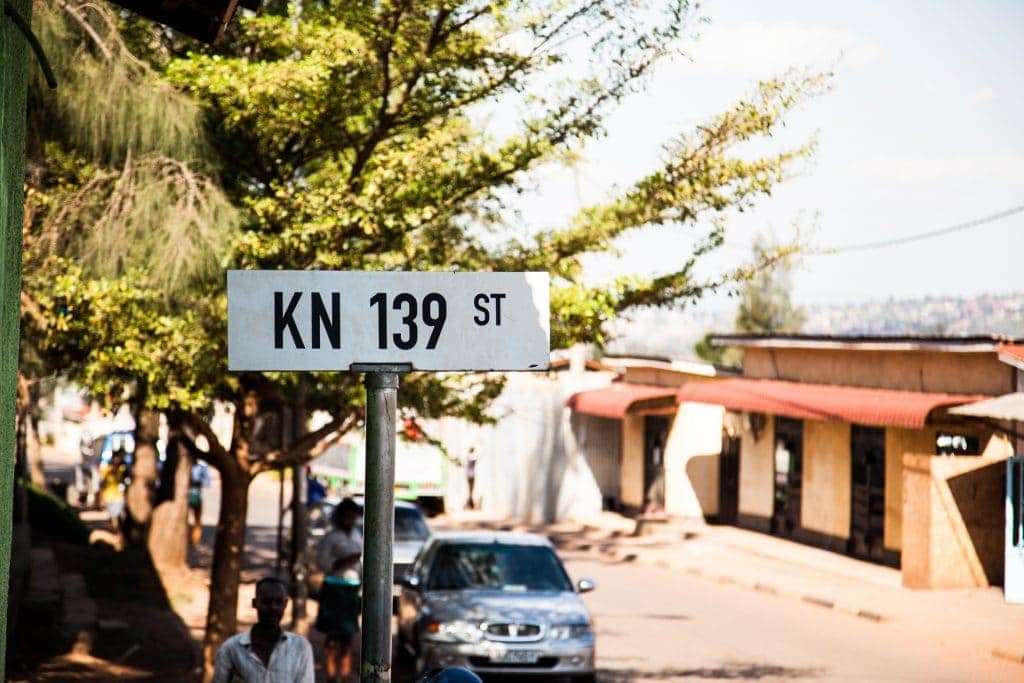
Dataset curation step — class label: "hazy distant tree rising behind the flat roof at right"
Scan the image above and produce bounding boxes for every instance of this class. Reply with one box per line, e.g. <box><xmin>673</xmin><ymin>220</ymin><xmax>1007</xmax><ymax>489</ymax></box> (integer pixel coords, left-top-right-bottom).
<box><xmin>736</xmin><ymin>234</ymin><xmax>806</xmax><ymax>334</ymax></box>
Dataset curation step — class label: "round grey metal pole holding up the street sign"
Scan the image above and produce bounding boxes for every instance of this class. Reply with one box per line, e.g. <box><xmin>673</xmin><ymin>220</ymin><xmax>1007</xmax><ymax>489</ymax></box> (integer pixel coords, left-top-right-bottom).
<box><xmin>352</xmin><ymin>365</ymin><xmax>409</xmax><ymax>683</ymax></box>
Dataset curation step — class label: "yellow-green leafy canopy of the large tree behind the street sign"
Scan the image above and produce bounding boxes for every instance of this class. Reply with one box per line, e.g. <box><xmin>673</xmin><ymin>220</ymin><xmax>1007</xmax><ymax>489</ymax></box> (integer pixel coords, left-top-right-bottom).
<box><xmin>27</xmin><ymin>0</ymin><xmax>827</xmax><ymax>420</ymax></box>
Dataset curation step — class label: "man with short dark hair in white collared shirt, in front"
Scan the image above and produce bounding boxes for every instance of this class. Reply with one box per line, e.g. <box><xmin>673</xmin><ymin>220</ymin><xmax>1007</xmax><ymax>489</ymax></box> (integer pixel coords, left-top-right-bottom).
<box><xmin>213</xmin><ymin>577</ymin><xmax>315</xmax><ymax>683</ymax></box>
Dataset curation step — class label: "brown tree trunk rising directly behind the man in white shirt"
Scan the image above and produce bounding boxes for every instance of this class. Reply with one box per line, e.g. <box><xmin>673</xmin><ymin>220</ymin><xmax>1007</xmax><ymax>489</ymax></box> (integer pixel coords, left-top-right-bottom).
<box><xmin>203</xmin><ymin>463</ymin><xmax>251</xmax><ymax>681</ymax></box>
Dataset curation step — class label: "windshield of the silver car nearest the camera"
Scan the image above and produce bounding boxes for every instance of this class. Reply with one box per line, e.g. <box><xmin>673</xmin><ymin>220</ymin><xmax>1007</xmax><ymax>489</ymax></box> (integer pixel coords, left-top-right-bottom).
<box><xmin>427</xmin><ymin>543</ymin><xmax>572</xmax><ymax>592</ymax></box>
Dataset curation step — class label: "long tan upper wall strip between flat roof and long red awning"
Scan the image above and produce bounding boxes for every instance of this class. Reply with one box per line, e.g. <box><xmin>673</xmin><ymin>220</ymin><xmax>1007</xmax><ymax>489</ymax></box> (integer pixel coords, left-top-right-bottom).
<box><xmin>743</xmin><ymin>348</ymin><xmax>1014</xmax><ymax>395</ymax></box>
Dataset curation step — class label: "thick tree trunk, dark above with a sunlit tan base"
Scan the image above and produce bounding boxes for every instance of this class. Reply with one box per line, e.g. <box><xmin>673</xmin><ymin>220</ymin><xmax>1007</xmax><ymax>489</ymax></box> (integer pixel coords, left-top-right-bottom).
<box><xmin>147</xmin><ymin>437</ymin><xmax>191</xmax><ymax>568</ymax></box>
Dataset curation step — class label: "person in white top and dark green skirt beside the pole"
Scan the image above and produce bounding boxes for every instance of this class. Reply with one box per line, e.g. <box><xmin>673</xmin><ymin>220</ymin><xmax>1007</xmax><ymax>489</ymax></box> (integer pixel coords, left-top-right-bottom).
<box><xmin>314</xmin><ymin>498</ymin><xmax>362</xmax><ymax>683</ymax></box>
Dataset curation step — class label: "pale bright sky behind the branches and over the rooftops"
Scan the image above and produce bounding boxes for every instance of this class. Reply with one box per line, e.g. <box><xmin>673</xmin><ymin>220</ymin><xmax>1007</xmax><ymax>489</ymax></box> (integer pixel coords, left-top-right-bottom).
<box><xmin>503</xmin><ymin>0</ymin><xmax>1024</xmax><ymax>305</ymax></box>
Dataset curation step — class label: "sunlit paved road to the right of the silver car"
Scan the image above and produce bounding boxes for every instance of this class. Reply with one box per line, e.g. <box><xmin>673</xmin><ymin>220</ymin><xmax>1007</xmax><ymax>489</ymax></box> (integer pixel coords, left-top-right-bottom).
<box><xmin>566</xmin><ymin>555</ymin><xmax>1024</xmax><ymax>682</ymax></box>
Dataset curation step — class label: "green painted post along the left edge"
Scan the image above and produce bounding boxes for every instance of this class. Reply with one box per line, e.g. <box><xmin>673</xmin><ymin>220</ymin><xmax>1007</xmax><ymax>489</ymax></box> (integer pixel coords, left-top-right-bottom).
<box><xmin>0</xmin><ymin>0</ymin><xmax>32</xmax><ymax>679</ymax></box>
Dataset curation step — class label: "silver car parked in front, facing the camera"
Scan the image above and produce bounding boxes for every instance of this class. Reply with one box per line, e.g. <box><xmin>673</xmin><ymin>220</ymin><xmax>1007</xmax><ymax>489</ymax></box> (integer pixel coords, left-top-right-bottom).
<box><xmin>398</xmin><ymin>531</ymin><xmax>594</xmax><ymax>681</ymax></box>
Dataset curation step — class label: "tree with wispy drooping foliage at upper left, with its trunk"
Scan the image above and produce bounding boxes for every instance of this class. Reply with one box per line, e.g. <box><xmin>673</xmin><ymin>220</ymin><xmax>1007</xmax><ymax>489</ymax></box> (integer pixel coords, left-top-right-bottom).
<box><xmin>20</xmin><ymin>0</ymin><xmax>237</xmax><ymax>564</ymax></box>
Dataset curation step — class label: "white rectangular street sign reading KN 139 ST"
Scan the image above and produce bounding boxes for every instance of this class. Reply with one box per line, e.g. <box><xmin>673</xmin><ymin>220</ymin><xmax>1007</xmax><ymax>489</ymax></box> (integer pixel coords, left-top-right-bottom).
<box><xmin>227</xmin><ymin>270</ymin><xmax>550</xmax><ymax>371</ymax></box>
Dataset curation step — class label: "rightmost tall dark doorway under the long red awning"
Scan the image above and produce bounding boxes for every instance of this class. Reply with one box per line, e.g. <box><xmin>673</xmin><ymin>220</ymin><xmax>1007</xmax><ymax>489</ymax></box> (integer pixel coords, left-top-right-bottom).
<box><xmin>847</xmin><ymin>425</ymin><xmax>886</xmax><ymax>562</ymax></box>
